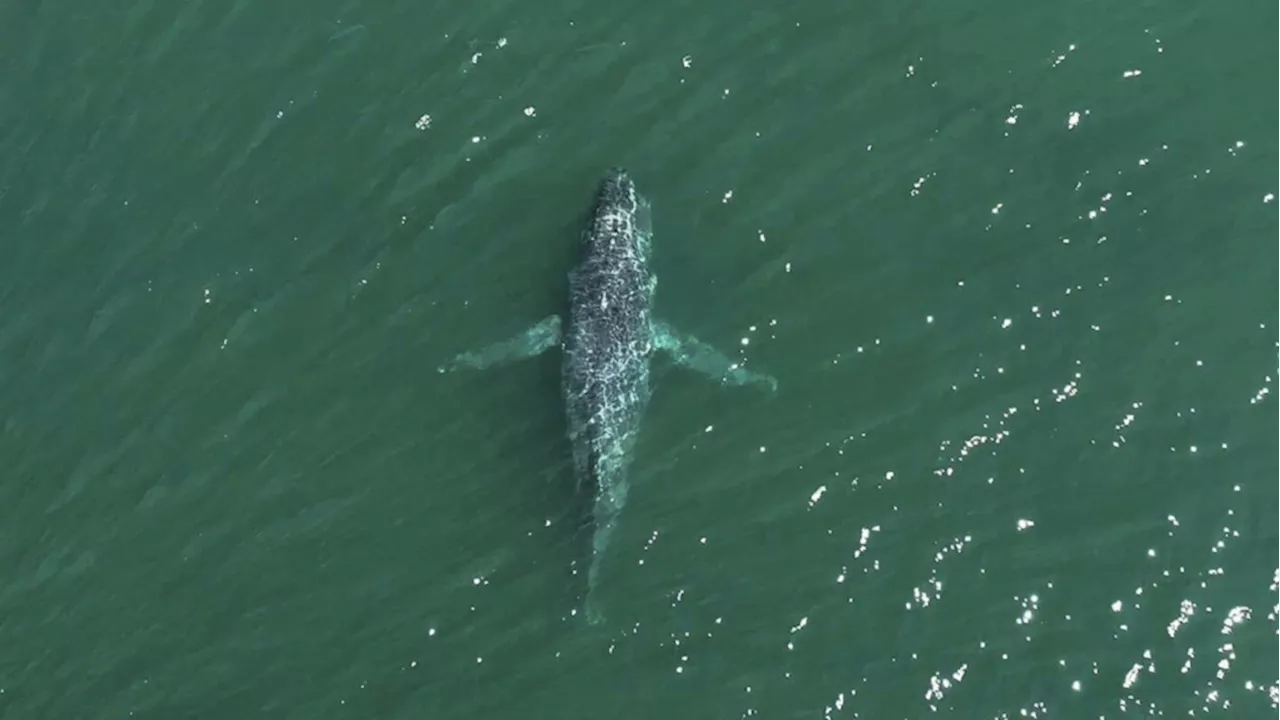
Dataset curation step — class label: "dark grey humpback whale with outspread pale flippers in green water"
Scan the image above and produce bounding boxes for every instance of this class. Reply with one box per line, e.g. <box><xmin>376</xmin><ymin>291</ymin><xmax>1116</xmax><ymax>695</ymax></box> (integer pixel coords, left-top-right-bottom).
<box><xmin>439</xmin><ymin>168</ymin><xmax>777</xmax><ymax>624</ymax></box>
